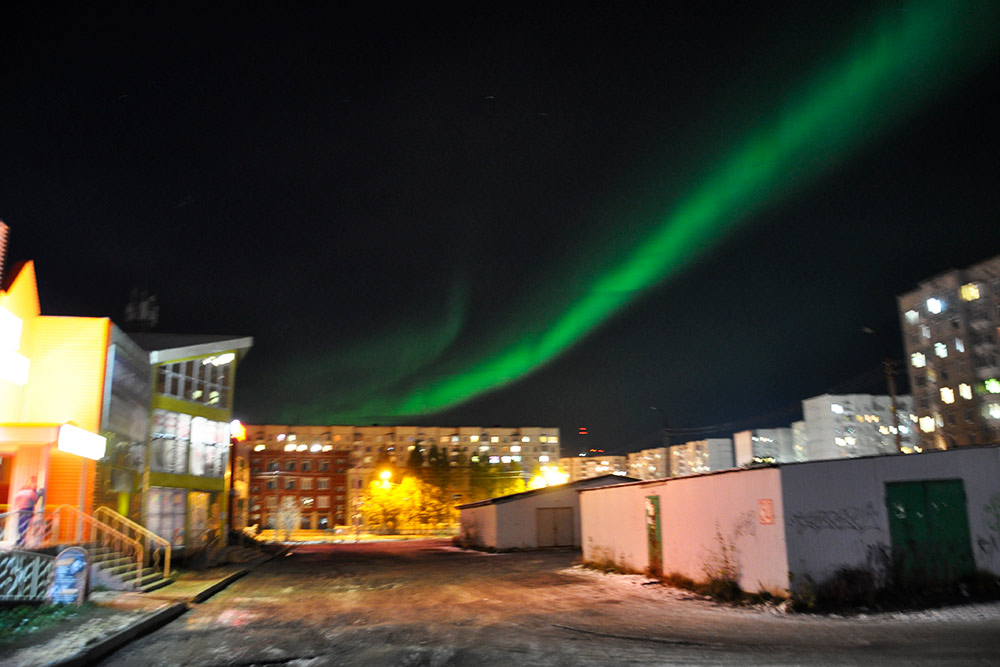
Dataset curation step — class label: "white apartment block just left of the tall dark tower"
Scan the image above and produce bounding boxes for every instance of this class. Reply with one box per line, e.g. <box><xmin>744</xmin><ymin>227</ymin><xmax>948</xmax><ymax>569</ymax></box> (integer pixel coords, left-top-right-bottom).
<box><xmin>800</xmin><ymin>394</ymin><xmax>919</xmax><ymax>461</ymax></box>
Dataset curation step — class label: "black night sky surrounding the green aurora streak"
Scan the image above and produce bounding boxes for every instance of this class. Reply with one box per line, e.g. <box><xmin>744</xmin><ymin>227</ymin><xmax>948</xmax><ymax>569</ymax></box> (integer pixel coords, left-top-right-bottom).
<box><xmin>0</xmin><ymin>1</ymin><xmax>1000</xmax><ymax>452</ymax></box>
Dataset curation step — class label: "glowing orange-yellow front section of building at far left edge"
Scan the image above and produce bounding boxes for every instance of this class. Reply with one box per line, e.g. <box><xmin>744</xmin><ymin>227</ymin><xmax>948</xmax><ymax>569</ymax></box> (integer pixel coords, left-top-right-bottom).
<box><xmin>0</xmin><ymin>262</ymin><xmax>112</xmax><ymax>535</ymax></box>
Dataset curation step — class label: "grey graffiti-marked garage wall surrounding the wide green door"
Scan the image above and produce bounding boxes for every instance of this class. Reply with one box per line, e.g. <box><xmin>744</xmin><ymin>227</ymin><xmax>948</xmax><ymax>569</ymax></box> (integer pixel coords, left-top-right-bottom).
<box><xmin>781</xmin><ymin>447</ymin><xmax>1000</xmax><ymax>581</ymax></box>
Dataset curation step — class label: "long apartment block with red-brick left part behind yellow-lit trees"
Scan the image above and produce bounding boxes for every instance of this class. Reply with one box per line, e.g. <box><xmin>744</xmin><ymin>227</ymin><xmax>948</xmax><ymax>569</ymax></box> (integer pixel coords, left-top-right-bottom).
<box><xmin>241</xmin><ymin>425</ymin><xmax>559</xmax><ymax>528</ymax></box>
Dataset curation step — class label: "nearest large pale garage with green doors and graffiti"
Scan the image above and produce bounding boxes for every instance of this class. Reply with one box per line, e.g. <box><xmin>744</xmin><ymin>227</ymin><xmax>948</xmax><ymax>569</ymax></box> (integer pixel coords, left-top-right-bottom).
<box><xmin>579</xmin><ymin>446</ymin><xmax>1000</xmax><ymax>592</ymax></box>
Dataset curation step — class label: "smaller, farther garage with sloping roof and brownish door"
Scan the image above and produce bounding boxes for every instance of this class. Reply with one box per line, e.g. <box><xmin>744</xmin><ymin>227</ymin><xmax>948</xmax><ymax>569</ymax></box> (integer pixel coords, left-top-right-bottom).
<box><xmin>458</xmin><ymin>475</ymin><xmax>635</xmax><ymax>551</ymax></box>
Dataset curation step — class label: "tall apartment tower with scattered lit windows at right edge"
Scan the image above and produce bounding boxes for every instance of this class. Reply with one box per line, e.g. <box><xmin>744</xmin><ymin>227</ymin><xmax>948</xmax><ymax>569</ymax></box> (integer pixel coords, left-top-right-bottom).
<box><xmin>898</xmin><ymin>256</ymin><xmax>1000</xmax><ymax>449</ymax></box>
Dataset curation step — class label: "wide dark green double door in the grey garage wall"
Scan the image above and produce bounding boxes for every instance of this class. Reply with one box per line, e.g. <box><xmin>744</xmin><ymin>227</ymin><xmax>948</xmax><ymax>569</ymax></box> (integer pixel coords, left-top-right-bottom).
<box><xmin>885</xmin><ymin>479</ymin><xmax>975</xmax><ymax>582</ymax></box>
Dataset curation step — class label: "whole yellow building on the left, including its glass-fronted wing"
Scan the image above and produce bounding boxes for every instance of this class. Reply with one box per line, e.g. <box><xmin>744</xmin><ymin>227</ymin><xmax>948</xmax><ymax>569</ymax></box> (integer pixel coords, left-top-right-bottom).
<box><xmin>0</xmin><ymin>262</ymin><xmax>253</xmax><ymax>548</ymax></box>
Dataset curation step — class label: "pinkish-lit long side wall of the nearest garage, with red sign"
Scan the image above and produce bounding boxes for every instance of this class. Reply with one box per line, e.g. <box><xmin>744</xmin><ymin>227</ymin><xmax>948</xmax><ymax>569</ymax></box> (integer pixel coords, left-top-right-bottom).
<box><xmin>580</xmin><ymin>468</ymin><xmax>788</xmax><ymax>592</ymax></box>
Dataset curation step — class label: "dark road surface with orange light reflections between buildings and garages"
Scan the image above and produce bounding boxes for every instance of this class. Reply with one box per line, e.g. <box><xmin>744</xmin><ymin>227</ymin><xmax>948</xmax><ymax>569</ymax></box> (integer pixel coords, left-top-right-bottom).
<box><xmin>102</xmin><ymin>541</ymin><xmax>1000</xmax><ymax>667</ymax></box>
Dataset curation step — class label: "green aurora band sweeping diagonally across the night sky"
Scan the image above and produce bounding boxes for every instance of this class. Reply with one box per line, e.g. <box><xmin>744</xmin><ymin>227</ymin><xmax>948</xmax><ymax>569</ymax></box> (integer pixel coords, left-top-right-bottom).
<box><xmin>280</xmin><ymin>0</ymin><xmax>1000</xmax><ymax>424</ymax></box>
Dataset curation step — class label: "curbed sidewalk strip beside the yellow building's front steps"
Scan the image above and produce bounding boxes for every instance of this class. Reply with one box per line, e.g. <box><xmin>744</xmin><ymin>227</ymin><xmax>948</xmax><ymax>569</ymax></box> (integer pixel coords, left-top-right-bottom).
<box><xmin>7</xmin><ymin>553</ymin><xmax>277</xmax><ymax>667</ymax></box>
